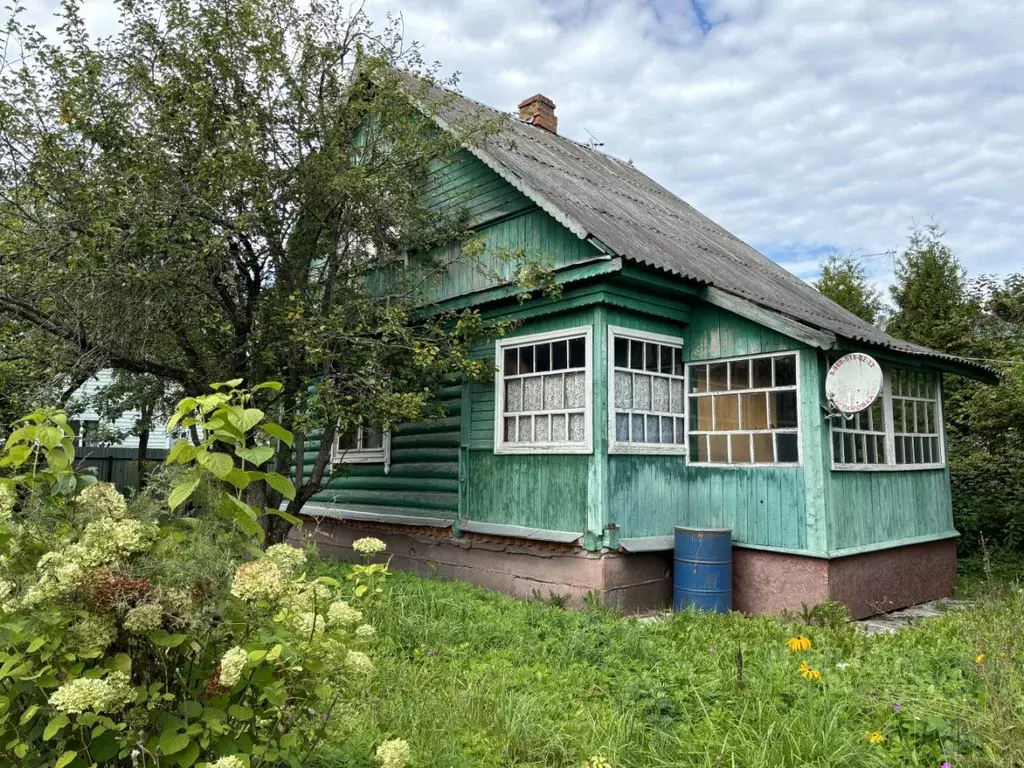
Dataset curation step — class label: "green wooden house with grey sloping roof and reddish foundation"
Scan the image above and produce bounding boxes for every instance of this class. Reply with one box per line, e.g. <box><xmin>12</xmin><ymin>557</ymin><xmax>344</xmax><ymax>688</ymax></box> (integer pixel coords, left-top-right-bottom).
<box><xmin>306</xmin><ymin>82</ymin><xmax>992</xmax><ymax>616</ymax></box>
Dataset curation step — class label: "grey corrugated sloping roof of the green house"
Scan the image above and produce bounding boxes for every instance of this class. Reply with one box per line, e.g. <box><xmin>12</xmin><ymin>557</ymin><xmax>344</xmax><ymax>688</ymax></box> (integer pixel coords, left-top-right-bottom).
<box><xmin>405</xmin><ymin>74</ymin><xmax>993</xmax><ymax>379</ymax></box>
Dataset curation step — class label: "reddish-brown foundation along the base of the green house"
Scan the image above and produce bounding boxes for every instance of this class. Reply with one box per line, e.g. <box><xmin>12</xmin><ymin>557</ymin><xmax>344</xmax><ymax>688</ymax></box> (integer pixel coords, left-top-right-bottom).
<box><xmin>293</xmin><ymin>518</ymin><xmax>956</xmax><ymax>618</ymax></box>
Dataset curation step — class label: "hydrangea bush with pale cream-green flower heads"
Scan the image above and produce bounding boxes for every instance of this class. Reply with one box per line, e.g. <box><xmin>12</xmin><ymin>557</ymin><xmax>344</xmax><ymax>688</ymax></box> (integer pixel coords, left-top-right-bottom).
<box><xmin>0</xmin><ymin>399</ymin><xmax>409</xmax><ymax>768</ymax></box>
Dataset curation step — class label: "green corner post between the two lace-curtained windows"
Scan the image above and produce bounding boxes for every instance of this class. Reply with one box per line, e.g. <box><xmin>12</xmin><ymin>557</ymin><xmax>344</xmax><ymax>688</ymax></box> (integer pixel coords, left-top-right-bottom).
<box><xmin>584</xmin><ymin>305</ymin><xmax>608</xmax><ymax>552</ymax></box>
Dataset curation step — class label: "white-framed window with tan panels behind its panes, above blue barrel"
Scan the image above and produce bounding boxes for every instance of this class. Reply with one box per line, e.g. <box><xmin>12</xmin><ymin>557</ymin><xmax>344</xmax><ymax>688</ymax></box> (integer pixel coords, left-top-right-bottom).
<box><xmin>686</xmin><ymin>352</ymin><xmax>801</xmax><ymax>466</ymax></box>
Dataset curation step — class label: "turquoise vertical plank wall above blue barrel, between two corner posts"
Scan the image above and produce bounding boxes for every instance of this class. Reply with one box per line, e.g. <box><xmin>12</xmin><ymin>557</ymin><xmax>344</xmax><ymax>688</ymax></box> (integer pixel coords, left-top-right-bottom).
<box><xmin>610</xmin><ymin>305</ymin><xmax>813</xmax><ymax>550</ymax></box>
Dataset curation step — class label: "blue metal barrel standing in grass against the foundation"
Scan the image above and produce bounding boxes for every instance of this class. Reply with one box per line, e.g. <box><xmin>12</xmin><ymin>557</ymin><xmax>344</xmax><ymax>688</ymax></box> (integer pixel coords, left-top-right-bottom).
<box><xmin>672</xmin><ymin>526</ymin><xmax>732</xmax><ymax>613</ymax></box>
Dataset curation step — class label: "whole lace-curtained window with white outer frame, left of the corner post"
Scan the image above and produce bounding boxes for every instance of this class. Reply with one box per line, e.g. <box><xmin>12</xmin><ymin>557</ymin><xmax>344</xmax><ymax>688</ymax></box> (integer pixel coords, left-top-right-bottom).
<box><xmin>495</xmin><ymin>327</ymin><xmax>593</xmax><ymax>454</ymax></box>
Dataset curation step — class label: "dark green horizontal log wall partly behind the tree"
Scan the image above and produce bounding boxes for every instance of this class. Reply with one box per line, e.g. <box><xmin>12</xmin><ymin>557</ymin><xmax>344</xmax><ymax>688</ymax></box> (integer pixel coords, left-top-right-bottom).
<box><xmin>305</xmin><ymin>386</ymin><xmax>462</xmax><ymax>519</ymax></box>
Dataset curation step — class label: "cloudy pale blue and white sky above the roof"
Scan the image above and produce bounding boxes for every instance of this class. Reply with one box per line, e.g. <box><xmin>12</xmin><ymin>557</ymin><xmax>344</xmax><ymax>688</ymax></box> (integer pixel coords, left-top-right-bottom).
<box><xmin>14</xmin><ymin>0</ymin><xmax>1024</xmax><ymax>290</ymax></box>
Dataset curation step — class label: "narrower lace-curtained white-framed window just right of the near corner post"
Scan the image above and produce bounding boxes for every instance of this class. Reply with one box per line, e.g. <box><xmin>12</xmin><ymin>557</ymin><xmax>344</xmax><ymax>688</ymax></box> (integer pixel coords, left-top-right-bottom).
<box><xmin>608</xmin><ymin>327</ymin><xmax>686</xmax><ymax>454</ymax></box>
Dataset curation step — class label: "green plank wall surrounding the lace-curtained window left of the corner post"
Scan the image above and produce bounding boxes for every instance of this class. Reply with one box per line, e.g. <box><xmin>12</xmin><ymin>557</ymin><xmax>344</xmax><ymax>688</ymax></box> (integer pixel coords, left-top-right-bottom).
<box><xmin>462</xmin><ymin>308</ymin><xmax>600</xmax><ymax>534</ymax></box>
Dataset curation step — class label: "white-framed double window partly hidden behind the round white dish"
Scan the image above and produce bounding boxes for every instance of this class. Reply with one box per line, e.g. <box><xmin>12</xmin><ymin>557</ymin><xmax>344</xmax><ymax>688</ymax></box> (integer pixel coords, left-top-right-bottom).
<box><xmin>830</xmin><ymin>366</ymin><xmax>945</xmax><ymax>470</ymax></box>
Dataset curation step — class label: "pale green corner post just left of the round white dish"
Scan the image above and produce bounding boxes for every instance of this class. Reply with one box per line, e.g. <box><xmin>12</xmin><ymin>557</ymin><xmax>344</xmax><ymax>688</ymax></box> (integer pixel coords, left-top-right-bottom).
<box><xmin>799</xmin><ymin>348</ymin><xmax>830</xmax><ymax>555</ymax></box>
